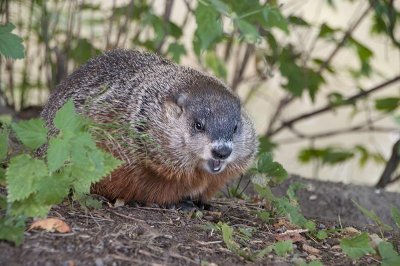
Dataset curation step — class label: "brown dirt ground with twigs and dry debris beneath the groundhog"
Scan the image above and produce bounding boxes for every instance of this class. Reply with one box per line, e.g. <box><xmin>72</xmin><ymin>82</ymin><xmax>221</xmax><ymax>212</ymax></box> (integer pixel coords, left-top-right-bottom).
<box><xmin>0</xmin><ymin>177</ymin><xmax>400</xmax><ymax>266</ymax></box>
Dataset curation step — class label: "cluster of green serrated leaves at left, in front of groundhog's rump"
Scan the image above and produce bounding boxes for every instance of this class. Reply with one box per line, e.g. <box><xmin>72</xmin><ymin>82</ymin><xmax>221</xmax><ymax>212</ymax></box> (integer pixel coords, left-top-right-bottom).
<box><xmin>0</xmin><ymin>101</ymin><xmax>122</xmax><ymax>244</ymax></box>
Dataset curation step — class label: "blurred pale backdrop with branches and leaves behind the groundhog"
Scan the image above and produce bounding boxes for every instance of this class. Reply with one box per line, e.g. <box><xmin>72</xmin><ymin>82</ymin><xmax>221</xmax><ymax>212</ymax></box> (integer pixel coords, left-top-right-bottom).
<box><xmin>0</xmin><ymin>0</ymin><xmax>400</xmax><ymax>191</ymax></box>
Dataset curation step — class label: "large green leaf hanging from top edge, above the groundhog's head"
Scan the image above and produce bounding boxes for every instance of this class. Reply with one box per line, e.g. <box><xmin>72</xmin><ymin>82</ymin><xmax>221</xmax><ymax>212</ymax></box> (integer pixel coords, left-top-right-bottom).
<box><xmin>195</xmin><ymin>2</ymin><xmax>222</xmax><ymax>50</ymax></box>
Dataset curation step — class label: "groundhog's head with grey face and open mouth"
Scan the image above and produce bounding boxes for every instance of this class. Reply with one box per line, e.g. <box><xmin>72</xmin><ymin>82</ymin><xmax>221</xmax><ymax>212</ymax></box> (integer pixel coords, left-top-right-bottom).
<box><xmin>162</xmin><ymin>80</ymin><xmax>257</xmax><ymax>174</ymax></box>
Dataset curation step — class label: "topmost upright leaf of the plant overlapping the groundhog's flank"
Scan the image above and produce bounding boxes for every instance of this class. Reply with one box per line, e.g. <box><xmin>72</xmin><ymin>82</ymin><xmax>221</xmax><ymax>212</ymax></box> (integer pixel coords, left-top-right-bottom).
<box><xmin>54</xmin><ymin>99</ymin><xmax>83</xmax><ymax>133</ymax></box>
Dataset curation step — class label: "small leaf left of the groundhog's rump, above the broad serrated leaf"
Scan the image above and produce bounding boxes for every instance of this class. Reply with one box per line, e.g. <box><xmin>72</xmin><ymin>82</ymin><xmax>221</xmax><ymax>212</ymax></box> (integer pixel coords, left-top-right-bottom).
<box><xmin>11</xmin><ymin>118</ymin><xmax>47</xmax><ymax>149</ymax></box>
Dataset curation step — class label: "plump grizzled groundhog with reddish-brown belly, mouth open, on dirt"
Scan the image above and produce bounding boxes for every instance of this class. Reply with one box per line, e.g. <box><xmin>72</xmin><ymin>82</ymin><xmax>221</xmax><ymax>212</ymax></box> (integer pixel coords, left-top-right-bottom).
<box><xmin>41</xmin><ymin>50</ymin><xmax>257</xmax><ymax>206</ymax></box>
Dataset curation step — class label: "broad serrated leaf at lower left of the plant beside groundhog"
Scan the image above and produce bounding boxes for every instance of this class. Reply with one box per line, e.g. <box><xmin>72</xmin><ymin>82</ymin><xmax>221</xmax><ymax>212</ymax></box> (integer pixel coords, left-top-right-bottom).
<box><xmin>6</xmin><ymin>154</ymin><xmax>48</xmax><ymax>202</ymax></box>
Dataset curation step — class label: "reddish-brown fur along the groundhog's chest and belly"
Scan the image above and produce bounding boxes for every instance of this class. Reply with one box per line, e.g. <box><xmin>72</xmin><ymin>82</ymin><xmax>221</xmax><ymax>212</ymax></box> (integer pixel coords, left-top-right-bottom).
<box><xmin>92</xmin><ymin>163</ymin><xmax>232</xmax><ymax>205</ymax></box>
